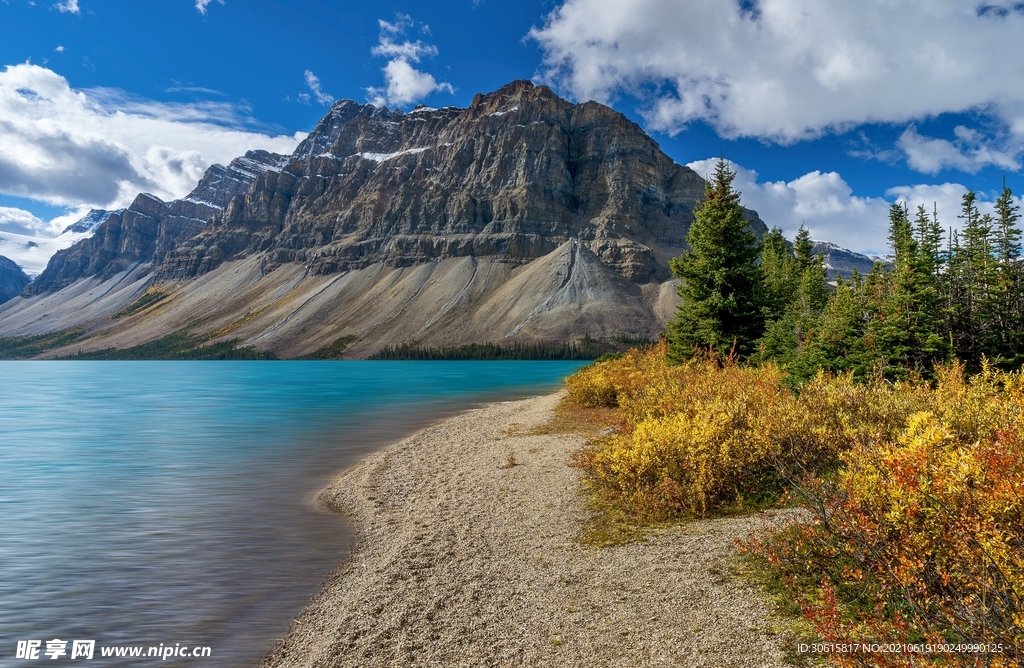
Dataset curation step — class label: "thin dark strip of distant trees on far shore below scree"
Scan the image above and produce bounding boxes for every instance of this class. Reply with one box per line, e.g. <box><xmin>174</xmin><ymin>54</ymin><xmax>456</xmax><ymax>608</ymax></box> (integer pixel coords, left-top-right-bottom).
<box><xmin>369</xmin><ymin>336</ymin><xmax>608</xmax><ymax>360</ymax></box>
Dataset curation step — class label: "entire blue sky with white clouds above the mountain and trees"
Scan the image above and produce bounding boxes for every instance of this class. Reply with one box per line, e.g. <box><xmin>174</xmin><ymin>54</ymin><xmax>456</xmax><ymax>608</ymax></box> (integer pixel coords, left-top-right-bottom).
<box><xmin>0</xmin><ymin>0</ymin><xmax>1024</xmax><ymax>264</ymax></box>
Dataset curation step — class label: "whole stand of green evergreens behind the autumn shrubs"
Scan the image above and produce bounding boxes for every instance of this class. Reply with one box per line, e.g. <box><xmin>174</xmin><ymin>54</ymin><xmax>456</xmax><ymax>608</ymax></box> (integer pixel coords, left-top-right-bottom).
<box><xmin>669</xmin><ymin>158</ymin><xmax>1024</xmax><ymax>382</ymax></box>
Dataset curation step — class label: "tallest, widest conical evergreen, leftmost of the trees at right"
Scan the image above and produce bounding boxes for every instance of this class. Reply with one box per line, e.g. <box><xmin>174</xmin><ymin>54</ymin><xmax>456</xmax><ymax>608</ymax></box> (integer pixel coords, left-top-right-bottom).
<box><xmin>668</xmin><ymin>159</ymin><xmax>765</xmax><ymax>364</ymax></box>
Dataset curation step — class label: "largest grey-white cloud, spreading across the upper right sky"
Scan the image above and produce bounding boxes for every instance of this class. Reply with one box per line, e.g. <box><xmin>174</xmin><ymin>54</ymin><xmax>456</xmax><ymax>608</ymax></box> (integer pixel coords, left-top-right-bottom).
<box><xmin>530</xmin><ymin>0</ymin><xmax>1024</xmax><ymax>158</ymax></box>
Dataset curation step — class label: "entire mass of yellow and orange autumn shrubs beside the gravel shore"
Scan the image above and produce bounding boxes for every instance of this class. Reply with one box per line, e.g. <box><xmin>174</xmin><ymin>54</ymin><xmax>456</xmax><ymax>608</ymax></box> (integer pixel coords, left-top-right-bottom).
<box><xmin>569</xmin><ymin>347</ymin><xmax>1024</xmax><ymax>666</ymax></box>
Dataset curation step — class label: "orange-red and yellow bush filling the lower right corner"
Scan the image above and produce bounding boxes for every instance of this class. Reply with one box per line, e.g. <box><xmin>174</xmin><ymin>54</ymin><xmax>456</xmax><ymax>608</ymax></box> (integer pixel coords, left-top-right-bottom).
<box><xmin>750</xmin><ymin>366</ymin><xmax>1024</xmax><ymax>666</ymax></box>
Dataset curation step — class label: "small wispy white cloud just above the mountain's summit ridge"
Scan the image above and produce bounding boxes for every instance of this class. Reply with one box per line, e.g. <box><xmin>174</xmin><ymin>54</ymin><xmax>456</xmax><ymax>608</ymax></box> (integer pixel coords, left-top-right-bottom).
<box><xmin>367</xmin><ymin>14</ymin><xmax>455</xmax><ymax>107</ymax></box>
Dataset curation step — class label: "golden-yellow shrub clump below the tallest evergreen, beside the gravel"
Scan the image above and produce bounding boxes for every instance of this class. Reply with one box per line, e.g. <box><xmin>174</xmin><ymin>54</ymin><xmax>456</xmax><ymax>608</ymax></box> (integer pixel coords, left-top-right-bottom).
<box><xmin>579</xmin><ymin>348</ymin><xmax>798</xmax><ymax>518</ymax></box>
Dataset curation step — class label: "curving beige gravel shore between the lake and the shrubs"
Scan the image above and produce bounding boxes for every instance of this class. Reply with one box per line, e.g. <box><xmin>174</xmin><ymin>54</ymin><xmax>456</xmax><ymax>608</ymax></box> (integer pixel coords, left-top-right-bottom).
<box><xmin>264</xmin><ymin>394</ymin><xmax>785</xmax><ymax>668</ymax></box>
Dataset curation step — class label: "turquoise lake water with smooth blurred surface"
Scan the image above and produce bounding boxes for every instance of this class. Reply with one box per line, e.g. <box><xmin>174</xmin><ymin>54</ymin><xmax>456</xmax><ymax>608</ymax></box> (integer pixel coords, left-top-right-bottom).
<box><xmin>0</xmin><ymin>362</ymin><xmax>582</xmax><ymax>667</ymax></box>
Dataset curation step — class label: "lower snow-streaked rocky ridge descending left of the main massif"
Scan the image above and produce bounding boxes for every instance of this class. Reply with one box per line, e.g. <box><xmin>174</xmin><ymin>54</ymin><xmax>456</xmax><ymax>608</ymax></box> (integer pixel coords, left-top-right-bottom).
<box><xmin>26</xmin><ymin>155</ymin><xmax>288</xmax><ymax>295</ymax></box>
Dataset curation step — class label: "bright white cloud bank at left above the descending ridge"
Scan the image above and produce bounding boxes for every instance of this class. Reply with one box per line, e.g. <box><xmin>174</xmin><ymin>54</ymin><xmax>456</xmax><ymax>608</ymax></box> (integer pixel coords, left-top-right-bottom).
<box><xmin>0</xmin><ymin>64</ymin><xmax>302</xmax><ymax>209</ymax></box>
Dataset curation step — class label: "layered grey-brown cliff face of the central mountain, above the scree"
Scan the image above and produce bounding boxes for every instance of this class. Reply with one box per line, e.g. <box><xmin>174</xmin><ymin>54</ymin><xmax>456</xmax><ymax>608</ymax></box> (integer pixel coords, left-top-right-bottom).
<box><xmin>161</xmin><ymin>81</ymin><xmax>764</xmax><ymax>283</ymax></box>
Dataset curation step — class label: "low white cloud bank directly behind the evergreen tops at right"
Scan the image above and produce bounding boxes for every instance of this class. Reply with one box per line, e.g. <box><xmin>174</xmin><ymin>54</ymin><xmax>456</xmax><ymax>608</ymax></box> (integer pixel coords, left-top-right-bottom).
<box><xmin>687</xmin><ymin>158</ymin><xmax>1024</xmax><ymax>255</ymax></box>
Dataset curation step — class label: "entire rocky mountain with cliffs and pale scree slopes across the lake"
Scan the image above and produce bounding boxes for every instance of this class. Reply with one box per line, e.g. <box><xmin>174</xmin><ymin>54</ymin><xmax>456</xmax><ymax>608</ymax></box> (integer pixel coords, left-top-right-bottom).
<box><xmin>0</xmin><ymin>81</ymin><xmax>767</xmax><ymax>357</ymax></box>
